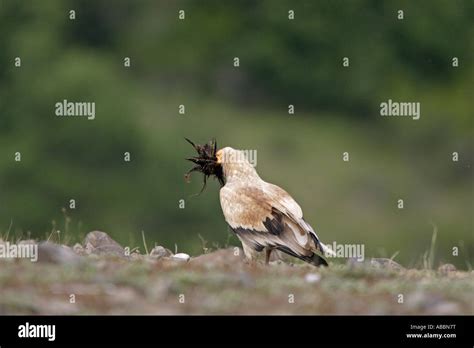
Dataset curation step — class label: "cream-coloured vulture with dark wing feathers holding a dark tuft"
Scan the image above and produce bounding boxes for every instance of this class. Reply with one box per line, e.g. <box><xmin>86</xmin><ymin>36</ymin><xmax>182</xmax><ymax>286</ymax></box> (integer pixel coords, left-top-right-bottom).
<box><xmin>186</xmin><ymin>139</ymin><xmax>332</xmax><ymax>266</ymax></box>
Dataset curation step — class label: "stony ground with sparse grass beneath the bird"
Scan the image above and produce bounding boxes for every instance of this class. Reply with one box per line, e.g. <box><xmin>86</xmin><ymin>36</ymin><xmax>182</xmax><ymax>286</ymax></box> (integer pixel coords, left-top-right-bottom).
<box><xmin>0</xmin><ymin>231</ymin><xmax>474</xmax><ymax>314</ymax></box>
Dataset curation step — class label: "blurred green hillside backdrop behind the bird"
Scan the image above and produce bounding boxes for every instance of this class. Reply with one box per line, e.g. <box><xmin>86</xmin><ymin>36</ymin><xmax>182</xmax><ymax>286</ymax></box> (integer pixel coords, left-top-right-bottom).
<box><xmin>0</xmin><ymin>0</ymin><xmax>474</xmax><ymax>268</ymax></box>
